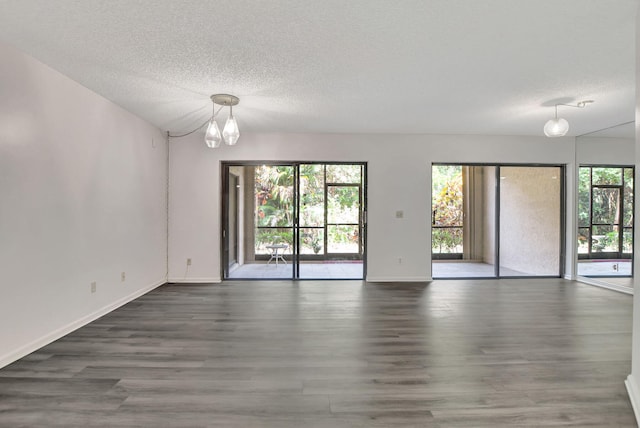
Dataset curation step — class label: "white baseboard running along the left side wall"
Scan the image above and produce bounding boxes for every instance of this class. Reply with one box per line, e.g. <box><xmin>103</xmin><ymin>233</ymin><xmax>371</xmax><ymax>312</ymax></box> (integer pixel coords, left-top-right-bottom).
<box><xmin>0</xmin><ymin>279</ymin><xmax>167</xmax><ymax>368</ymax></box>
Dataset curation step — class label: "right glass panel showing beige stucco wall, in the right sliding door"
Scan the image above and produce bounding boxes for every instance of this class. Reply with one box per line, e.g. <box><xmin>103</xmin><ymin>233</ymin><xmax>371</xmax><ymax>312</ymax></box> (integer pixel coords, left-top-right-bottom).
<box><xmin>499</xmin><ymin>166</ymin><xmax>562</xmax><ymax>277</ymax></box>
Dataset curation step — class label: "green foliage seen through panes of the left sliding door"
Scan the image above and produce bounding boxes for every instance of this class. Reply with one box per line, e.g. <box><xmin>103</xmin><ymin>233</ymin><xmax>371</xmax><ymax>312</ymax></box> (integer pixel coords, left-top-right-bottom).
<box><xmin>255</xmin><ymin>164</ymin><xmax>362</xmax><ymax>255</ymax></box>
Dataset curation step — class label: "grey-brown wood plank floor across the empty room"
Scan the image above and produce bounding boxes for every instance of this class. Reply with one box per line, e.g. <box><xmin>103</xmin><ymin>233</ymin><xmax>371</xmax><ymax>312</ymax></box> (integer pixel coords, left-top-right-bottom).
<box><xmin>0</xmin><ymin>279</ymin><xmax>636</xmax><ymax>428</ymax></box>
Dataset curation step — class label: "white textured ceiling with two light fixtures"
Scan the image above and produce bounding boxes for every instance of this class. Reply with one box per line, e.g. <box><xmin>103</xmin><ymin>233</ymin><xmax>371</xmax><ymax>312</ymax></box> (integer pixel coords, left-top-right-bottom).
<box><xmin>0</xmin><ymin>0</ymin><xmax>638</xmax><ymax>135</ymax></box>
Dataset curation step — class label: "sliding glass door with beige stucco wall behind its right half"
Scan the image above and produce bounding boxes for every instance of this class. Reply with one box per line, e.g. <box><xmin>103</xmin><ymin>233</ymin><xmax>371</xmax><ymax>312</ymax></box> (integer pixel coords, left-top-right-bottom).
<box><xmin>431</xmin><ymin>164</ymin><xmax>564</xmax><ymax>278</ymax></box>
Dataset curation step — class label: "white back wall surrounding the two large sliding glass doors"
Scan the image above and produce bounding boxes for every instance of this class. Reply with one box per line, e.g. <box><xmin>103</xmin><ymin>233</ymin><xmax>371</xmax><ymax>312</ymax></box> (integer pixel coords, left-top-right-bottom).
<box><xmin>169</xmin><ymin>132</ymin><xmax>575</xmax><ymax>282</ymax></box>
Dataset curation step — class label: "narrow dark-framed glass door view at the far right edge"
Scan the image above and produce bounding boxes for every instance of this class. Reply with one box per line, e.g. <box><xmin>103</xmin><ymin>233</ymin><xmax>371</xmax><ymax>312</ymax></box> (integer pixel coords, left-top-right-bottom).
<box><xmin>578</xmin><ymin>166</ymin><xmax>634</xmax><ymax>277</ymax></box>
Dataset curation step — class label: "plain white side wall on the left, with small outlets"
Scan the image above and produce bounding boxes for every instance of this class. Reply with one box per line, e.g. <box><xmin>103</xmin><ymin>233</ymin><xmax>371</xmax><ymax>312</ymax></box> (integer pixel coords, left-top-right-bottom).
<box><xmin>0</xmin><ymin>44</ymin><xmax>166</xmax><ymax>367</ymax></box>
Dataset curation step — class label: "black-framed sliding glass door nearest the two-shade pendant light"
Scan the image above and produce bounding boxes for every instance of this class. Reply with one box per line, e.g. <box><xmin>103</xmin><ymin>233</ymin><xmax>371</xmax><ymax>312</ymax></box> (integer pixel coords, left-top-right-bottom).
<box><xmin>222</xmin><ymin>163</ymin><xmax>365</xmax><ymax>279</ymax></box>
